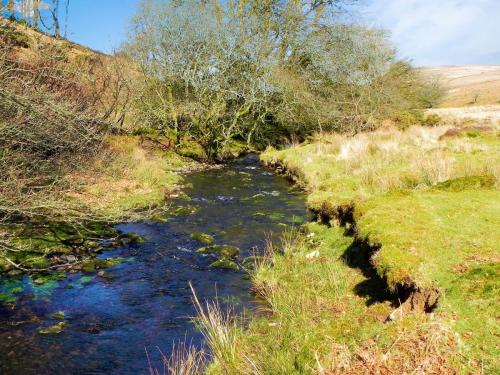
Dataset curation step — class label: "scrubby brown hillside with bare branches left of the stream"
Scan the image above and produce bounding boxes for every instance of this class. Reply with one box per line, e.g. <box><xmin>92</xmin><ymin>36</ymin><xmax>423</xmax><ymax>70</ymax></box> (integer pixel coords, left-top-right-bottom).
<box><xmin>0</xmin><ymin>21</ymin><xmax>195</xmax><ymax>271</ymax></box>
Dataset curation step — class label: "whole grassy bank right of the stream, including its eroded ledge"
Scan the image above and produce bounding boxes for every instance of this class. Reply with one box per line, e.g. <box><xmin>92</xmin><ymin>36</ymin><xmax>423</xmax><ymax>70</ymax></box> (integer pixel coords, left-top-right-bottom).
<box><xmin>201</xmin><ymin>127</ymin><xmax>500</xmax><ymax>374</ymax></box>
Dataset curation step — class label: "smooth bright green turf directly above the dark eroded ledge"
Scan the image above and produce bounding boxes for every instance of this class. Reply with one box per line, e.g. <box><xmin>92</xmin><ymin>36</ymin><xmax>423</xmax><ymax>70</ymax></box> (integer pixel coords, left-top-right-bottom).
<box><xmin>355</xmin><ymin>189</ymin><xmax>500</xmax><ymax>288</ymax></box>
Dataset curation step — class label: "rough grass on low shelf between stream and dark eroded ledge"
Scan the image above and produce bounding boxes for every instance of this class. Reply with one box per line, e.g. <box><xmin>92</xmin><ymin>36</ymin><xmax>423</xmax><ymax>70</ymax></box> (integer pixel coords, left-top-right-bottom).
<box><xmin>209</xmin><ymin>223</ymin><xmax>459</xmax><ymax>374</ymax></box>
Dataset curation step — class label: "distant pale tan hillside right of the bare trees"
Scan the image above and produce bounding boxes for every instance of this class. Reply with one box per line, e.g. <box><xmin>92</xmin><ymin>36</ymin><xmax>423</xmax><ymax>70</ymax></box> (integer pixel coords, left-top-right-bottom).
<box><xmin>421</xmin><ymin>65</ymin><xmax>500</xmax><ymax>107</ymax></box>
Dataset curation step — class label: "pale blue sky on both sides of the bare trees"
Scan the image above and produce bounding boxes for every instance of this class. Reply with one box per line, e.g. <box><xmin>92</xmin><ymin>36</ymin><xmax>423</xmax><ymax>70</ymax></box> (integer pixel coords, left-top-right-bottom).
<box><xmin>45</xmin><ymin>0</ymin><xmax>500</xmax><ymax>65</ymax></box>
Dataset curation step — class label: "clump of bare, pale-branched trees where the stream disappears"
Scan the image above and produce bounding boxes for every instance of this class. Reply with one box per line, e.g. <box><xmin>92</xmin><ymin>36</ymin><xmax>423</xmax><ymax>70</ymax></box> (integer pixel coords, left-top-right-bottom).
<box><xmin>126</xmin><ymin>0</ymin><xmax>439</xmax><ymax>158</ymax></box>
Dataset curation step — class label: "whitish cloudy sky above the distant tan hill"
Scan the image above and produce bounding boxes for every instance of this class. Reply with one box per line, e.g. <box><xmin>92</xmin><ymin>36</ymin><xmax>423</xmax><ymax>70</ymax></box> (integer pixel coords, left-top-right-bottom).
<box><xmin>363</xmin><ymin>0</ymin><xmax>500</xmax><ymax>65</ymax></box>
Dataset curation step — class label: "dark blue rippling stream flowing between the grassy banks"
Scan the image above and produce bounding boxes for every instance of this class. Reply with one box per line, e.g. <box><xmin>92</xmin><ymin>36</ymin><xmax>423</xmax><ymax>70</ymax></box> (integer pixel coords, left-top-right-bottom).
<box><xmin>0</xmin><ymin>156</ymin><xmax>307</xmax><ymax>375</ymax></box>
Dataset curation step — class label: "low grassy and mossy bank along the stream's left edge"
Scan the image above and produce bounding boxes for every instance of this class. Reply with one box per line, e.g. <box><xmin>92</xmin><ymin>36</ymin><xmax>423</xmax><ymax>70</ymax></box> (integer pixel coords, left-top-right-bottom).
<box><xmin>0</xmin><ymin>136</ymin><xmax>203</xmax><ymax>275</ymax></box>
